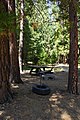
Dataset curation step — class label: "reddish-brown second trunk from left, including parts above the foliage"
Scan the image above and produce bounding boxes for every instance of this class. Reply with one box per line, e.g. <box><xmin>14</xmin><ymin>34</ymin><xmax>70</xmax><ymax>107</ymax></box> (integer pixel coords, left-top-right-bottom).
<box><xmin>8</xmin><ymin>0</ymin><xmax>23</xmax><ymax>83</ymax></box>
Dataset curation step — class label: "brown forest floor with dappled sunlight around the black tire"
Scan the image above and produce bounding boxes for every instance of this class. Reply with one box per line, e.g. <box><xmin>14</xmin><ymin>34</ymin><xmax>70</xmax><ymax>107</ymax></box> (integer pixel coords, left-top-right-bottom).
<box><xmin>0</xmin><ymin>65</ymin><xmax>80</xmax><ymax>120</ymax></box>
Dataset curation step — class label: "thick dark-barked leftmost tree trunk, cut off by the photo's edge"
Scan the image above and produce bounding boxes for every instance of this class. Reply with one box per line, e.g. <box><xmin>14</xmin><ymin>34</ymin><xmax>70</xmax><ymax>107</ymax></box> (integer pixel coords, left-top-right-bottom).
<box><xmin>0</xmin><ymin>0</ymin><xmax>12</xmax><ymax>103</ymax></box>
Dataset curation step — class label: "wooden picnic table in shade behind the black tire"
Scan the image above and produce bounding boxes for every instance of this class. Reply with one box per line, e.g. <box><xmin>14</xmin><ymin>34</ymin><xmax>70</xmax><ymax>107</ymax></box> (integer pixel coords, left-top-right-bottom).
<box><xmin>29</xmin><ymin>65</ymin><xmax>54</xmax><ymax>74</ymax></box>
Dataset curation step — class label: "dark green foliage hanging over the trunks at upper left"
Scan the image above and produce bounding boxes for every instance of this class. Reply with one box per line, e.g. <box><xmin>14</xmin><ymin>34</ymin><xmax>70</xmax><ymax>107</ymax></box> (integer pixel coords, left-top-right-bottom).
<box><xmin>0</xmin><ymin>2</ymin><xmax>15</xmax><ymax>32</ymax></box>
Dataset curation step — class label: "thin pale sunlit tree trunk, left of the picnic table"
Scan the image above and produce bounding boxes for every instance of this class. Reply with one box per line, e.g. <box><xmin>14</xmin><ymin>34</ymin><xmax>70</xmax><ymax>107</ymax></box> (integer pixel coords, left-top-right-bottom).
<box><xmin>19</xmin><ymin>0</ymin><xmax>24</xmax><ymax>72</ymax></box>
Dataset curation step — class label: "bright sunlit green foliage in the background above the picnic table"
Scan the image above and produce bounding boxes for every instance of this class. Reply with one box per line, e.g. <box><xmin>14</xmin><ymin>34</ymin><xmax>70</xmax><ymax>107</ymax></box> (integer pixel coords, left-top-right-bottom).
<box><xmin>21</xmin><ymin>1</ymin><xmax>69</xmax><ymax>64</ymax></box>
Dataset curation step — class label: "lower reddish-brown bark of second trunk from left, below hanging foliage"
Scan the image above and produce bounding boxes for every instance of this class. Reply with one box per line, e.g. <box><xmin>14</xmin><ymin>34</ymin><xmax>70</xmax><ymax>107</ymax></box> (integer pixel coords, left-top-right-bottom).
<box><xmin>9</xmin><ymin>32</ymin><xmax>23</xmax><ymax>83</ymax></box>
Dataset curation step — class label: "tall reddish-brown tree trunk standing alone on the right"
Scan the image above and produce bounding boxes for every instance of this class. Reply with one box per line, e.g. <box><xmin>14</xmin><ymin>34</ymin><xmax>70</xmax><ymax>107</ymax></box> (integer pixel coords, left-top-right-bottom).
<box><xmin>68</xmin><ymin>0</ymin><xmax>78</xmax><ymax>94</ymax></box>
